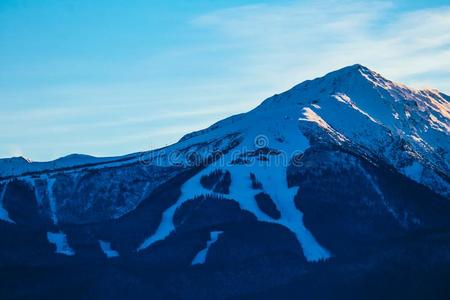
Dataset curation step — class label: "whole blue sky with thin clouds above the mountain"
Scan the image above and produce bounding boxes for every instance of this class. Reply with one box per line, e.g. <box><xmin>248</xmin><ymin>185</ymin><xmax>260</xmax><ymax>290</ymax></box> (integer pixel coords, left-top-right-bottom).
<box><xmin>0</xmin><ymin>0</ymin><xmax>450</xmax><ymax>160</ymax></box>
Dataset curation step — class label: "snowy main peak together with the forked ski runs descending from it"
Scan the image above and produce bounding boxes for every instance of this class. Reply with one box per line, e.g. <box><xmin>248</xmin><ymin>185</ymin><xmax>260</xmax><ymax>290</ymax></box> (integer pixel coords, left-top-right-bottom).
<box><xmin>138</xmin><ymin>65</ymin><xmax>450</xmax><ymax>261</ymax></box>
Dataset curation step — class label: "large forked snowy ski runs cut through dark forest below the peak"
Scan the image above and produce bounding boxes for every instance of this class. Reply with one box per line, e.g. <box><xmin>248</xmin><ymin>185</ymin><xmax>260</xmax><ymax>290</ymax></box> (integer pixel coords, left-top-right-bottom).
<box><xmin>138</xmin><ymin>128</ymin><xmax>331</xmax><ymax>262</ymax></box>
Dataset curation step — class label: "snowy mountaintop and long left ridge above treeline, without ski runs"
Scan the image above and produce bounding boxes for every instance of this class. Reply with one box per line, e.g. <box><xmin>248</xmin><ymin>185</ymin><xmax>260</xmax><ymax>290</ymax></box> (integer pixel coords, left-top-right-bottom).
<box><xmin>0</xmin><ymin>64</ymin><xmax>450</xmax><ymax>193</ymax></box>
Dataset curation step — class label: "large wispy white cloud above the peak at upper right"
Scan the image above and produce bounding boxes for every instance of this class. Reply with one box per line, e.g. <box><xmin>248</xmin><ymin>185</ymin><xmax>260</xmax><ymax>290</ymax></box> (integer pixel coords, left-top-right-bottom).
<box><xmin>193</xmin><ymin>1</ymin><xmax>450</xmax><ymax>92</ymax></box>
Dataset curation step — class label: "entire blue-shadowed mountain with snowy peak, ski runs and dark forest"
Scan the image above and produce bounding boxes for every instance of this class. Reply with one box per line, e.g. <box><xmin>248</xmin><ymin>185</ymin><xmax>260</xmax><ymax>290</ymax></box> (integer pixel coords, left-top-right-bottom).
<box><xmin>0</xmin><ymin>65</ymin><xmax>450</xmax><ymax>299</ymax></box>
